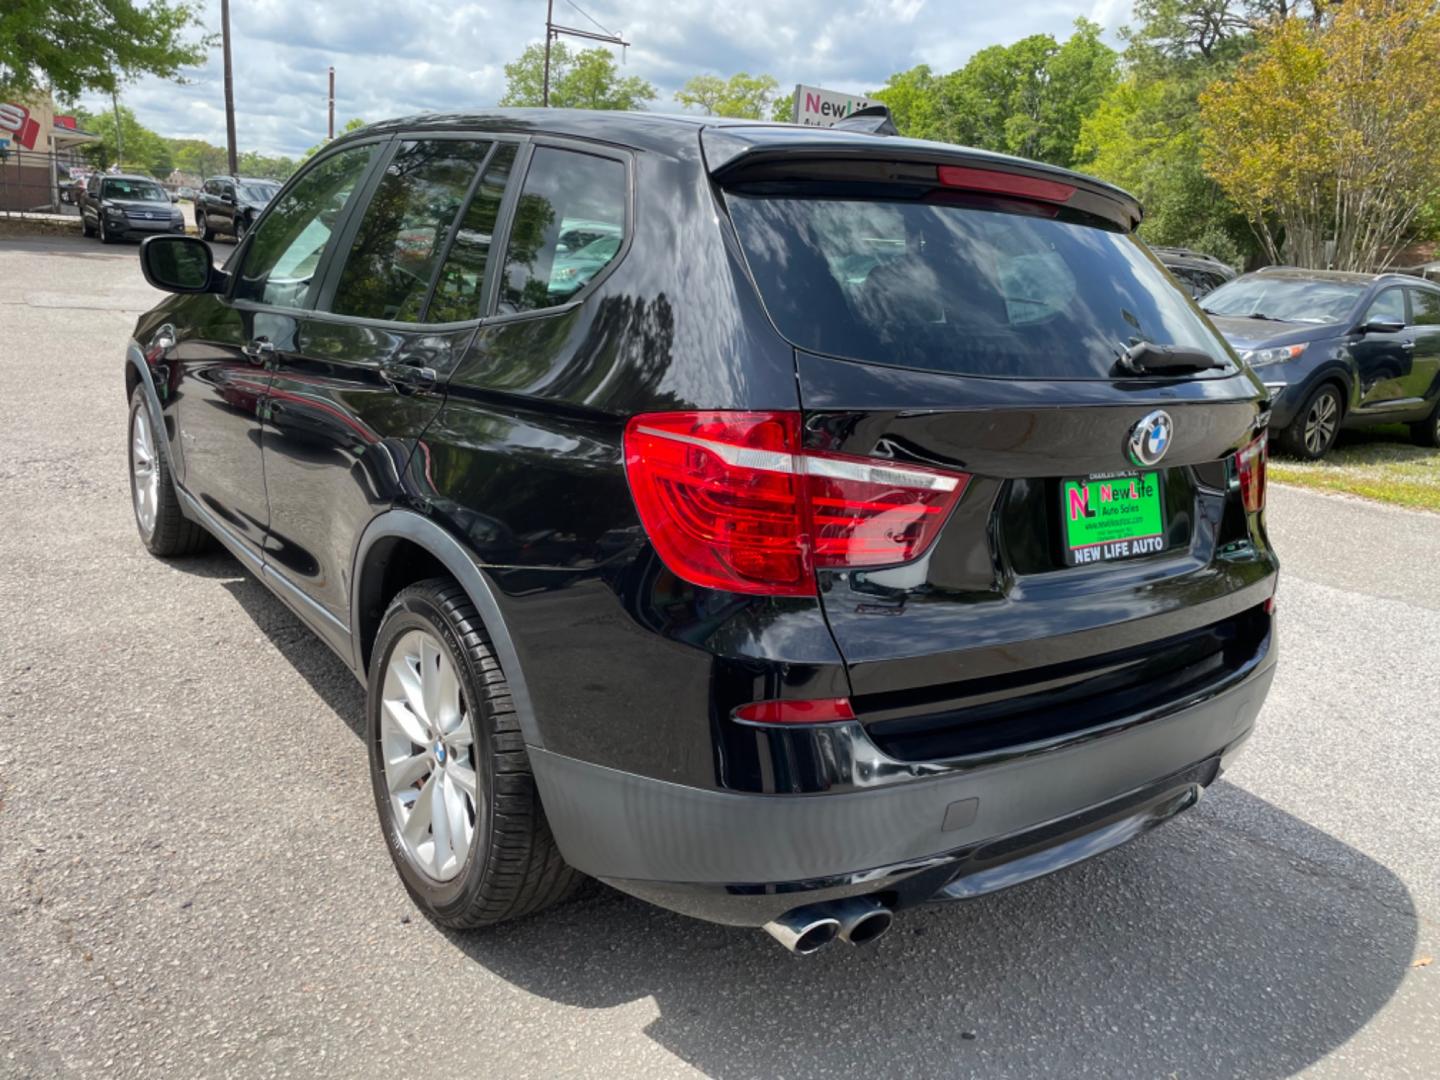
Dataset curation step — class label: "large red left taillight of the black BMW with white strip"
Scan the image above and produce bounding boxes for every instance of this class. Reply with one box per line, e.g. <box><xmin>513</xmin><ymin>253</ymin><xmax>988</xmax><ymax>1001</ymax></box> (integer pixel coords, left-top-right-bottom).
<box><xmin>625</xmin><ymin>412</ymin><xmax>969</xmax><ymax>596</ymax></box>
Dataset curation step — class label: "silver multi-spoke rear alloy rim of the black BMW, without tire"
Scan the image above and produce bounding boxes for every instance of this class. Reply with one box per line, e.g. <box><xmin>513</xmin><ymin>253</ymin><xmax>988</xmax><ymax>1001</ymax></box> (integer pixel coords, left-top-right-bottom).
<box><xmin>380</xmin><ymin>629</ymin><xmax>477</xmax><ymax>881</ymax></box>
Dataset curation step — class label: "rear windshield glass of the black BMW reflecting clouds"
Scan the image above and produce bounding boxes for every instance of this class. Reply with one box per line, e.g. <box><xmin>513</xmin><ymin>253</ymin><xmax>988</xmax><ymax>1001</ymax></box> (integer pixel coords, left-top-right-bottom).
<box><xmin>726</xmin><ymin>190</ymin><xmax>1234</xmax><ymax>379</ymax></box>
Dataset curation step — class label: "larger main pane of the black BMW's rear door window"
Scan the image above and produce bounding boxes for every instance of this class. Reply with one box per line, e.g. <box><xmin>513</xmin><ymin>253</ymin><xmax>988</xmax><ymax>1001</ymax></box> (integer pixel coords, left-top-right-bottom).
<box><xmin>331</xmin><ymin>140</ymin><xmax>490</xmax><ymax>323</ymax></box>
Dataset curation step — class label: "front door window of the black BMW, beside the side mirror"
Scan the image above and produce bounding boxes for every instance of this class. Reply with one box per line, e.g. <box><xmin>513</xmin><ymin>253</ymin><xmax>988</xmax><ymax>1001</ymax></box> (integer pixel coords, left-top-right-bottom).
<box><xmin>235</xmin><ymin>144</ymin><xmax>376</xmax><ymax>308</ymax></box>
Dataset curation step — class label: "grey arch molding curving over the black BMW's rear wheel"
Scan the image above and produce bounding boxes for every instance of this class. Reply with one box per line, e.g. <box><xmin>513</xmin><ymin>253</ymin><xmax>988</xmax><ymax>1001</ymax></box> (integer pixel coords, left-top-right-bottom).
<box><xmin>350</xmin><ymin>508</ymin><xmax>544</xmax><ymax>746</ymax></box>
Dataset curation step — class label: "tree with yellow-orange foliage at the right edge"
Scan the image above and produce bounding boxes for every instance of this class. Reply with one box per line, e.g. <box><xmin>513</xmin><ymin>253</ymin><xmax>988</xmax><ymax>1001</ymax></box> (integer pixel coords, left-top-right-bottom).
<box><xmin>1200</xmin><ymin>0</ymin><xmax>1440</xmax><ymax>271</ymax></box>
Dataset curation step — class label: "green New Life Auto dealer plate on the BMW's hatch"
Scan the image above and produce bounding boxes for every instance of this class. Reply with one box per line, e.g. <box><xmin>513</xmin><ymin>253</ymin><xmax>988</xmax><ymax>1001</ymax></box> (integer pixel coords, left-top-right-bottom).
<box><xmin>1060</xmin><ymin>472</ymin><xmax>1165</xmax><ymax>566</ymax></box>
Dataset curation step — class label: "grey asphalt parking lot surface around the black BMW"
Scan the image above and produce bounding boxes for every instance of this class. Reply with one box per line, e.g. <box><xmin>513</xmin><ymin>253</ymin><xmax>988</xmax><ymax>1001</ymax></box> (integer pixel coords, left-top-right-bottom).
<box><xmin>0</xmin><ymin>233</ymin><xmax>1440</xmax><ymax>1077</ymax></box>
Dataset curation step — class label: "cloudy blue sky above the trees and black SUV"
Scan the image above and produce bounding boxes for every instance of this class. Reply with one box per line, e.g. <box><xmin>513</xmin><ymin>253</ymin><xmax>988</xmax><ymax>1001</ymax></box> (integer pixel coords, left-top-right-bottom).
<box><xmin>82</xmin><ymin>0</ymin><xmax>1129</xmax><ymax>156</ymax></box>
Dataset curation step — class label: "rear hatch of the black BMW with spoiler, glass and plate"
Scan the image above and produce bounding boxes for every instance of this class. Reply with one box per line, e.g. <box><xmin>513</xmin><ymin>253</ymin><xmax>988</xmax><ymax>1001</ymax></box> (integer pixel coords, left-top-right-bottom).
<box><xmin>706</xmin><ymin>128</ymin><xmax>1276</xmax><ymax>760</ymax></box>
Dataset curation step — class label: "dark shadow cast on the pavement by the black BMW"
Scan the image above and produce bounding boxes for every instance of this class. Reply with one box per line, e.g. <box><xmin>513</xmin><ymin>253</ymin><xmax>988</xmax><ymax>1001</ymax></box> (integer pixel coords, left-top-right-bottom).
<box><xmin>205</xmin><ymin>556</ymin><xmax>1417</xmax><ymax>1077</ymax></box>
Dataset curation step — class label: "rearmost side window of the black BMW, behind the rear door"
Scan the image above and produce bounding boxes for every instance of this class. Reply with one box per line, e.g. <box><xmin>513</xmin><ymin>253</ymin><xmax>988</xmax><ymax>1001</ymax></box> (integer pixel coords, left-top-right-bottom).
<box><xmin>498</xmin><ymin>147</ymin><xmax>626</xmax><ymax>314</ymax></box>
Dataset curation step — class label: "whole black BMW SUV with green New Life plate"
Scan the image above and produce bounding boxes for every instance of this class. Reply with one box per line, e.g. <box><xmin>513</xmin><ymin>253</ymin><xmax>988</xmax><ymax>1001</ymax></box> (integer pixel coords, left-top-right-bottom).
<box><xmin>125</xmin><ymin>109</ymin><xmax>1277</xmax><ymax>952</ymax></box>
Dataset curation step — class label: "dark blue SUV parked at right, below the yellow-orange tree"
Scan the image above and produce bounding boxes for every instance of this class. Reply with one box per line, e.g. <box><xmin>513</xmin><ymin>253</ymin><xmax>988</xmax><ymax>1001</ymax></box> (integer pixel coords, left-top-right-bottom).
<box><xmin>1201</xmin><ymin>266</ymin><xmax>1440</xmax><ymax>459</ymax></box>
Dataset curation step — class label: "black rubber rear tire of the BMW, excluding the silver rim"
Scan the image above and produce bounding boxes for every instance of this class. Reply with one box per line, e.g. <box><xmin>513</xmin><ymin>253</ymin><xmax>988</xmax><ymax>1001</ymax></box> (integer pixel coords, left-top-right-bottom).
<box><xmin>366</xmin><ymin>577</ymin><xmax>585</xmax><ymax>929</ymax></box>
